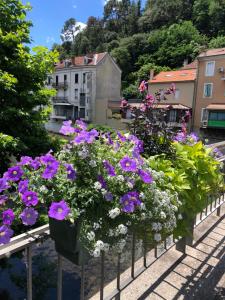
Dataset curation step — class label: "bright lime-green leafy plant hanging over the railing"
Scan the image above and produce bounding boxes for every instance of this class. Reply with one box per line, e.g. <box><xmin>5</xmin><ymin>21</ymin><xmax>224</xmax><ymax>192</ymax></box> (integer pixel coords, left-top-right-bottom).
<box><xmin>149</xmin><ymin>142</ymin><xmax>224</xmax><ymax>236</ymax></box>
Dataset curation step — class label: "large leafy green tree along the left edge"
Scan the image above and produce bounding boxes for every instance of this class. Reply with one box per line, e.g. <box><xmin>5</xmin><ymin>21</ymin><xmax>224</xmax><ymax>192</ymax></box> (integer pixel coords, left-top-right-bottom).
<box><xmin>0</xmin><ymin>0</ymin><xmax>57</xmax><ymax>164</ymax></box>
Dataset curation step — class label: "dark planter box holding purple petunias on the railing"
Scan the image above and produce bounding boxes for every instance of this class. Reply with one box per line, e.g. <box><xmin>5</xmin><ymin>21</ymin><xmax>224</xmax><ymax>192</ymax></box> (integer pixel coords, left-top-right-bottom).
<box><xmin>49</xmin><ymin>218</ymin><xmax>89</xmax><ymax>265</ymax></box>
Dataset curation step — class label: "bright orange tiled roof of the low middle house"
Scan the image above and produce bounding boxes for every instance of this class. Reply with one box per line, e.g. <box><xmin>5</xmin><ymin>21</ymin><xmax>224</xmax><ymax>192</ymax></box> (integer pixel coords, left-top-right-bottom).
<box><xmin>149</xmin><ymin>69</ymin><xmax>196</xmax><ymax>84</ymax></box>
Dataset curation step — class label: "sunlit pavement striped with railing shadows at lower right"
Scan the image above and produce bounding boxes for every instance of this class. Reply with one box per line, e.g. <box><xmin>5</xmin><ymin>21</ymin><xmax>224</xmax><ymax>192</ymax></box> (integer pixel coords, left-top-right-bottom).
<box><xmin>91</xmin><ymin>205</ymin><xmax>225</xmax><ymax>300</ymax></box>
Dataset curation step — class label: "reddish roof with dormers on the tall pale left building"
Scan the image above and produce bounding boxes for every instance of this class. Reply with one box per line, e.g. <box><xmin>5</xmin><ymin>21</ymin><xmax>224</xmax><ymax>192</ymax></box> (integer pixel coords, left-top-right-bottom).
<box><xmin>55</xmin><ymin>52</ymin><xmax>107</xmax><ymax>69</ymax></box>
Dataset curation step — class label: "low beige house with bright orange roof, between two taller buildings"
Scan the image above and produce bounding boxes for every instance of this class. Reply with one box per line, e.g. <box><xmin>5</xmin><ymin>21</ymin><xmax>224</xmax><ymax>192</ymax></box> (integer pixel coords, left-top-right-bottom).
<box><xmin>149</xmin><ymin>67</ymin><xmax>196</xmax><ymax>128</ymax></box>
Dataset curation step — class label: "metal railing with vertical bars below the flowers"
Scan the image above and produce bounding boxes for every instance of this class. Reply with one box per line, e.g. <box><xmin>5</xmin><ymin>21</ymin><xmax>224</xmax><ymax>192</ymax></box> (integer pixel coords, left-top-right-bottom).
<box><xmin>0</xmin><ymin>146</ymin><xmax>225</xmax><ymax>300</ymax></box>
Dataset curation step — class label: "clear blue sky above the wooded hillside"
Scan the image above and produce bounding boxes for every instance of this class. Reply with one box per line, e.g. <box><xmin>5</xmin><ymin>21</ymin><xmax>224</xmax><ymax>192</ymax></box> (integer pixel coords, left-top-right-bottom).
<box><xmin>23</xmin><ymin>0</ymin><xmax>145</xmax><ymax>48</ymax></box>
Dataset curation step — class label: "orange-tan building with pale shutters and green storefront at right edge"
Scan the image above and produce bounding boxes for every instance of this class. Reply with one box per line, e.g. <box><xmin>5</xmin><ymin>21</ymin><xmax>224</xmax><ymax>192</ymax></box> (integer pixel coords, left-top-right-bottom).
<box><xmin>193</xmin><ymin>48</ymin><xmax>225</xmax><ymax>131</ymax></box>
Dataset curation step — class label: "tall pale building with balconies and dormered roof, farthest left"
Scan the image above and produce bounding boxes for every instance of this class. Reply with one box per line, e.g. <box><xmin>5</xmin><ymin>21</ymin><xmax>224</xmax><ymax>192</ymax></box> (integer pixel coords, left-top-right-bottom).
<box><xmin>46</xmin><ymin>52</ymin><xmax>121</xmax><ymax>132</ymax></box>
